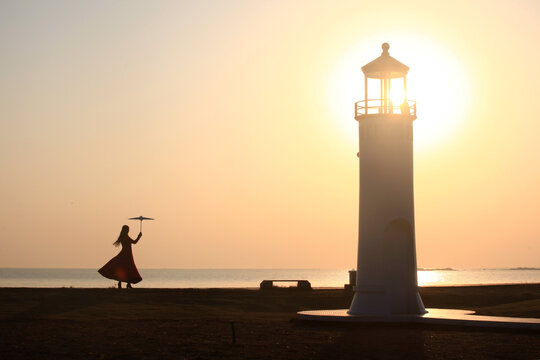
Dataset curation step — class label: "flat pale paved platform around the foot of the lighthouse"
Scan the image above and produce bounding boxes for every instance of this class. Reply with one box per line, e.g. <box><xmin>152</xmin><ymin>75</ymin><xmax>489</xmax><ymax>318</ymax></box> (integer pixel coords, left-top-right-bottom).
<box><xmin>298</xmin><ymin>309</ymin><xmax>540</xmax><ymax>330</ymax></box>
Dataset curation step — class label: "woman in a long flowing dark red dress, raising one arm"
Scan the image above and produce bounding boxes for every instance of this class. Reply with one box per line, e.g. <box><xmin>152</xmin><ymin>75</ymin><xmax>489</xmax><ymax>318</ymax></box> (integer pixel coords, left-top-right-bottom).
<box><xmin>98</xmin><ymin>225</ymin><xmax>142</xmax><ymax>289</ymax></box>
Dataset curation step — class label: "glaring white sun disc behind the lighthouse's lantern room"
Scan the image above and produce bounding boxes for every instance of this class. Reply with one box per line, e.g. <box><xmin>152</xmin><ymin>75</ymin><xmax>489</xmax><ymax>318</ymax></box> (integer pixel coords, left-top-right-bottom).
<box><xmin>327</xmin><ymin>34</ymin><xmax>470</xmax><ymax>150</ymax></box>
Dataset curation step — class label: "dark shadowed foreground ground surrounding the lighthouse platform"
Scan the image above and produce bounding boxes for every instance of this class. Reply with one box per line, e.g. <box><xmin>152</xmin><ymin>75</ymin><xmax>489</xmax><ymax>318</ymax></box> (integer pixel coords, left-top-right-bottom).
<box><xmin>0</xmin><ymin>284</ymin><xmax>540</xmax><ymax>360</ymax></box>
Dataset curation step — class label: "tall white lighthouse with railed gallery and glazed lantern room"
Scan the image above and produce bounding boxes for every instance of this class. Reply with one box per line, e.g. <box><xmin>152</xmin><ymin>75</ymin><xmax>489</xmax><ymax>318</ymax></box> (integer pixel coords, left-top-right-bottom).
<box><xmin>348</xmin><ymin>43</ymin><xmax>426</xmax><ymax>316</ymax></box>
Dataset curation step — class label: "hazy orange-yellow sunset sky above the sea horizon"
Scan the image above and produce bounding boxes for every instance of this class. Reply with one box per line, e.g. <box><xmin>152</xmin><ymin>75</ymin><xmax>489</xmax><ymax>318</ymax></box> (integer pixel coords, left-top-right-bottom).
<box><xmin>0</xmin><ymin>0</ymin><xmax>540</xmax><ymax>269</ymax></box>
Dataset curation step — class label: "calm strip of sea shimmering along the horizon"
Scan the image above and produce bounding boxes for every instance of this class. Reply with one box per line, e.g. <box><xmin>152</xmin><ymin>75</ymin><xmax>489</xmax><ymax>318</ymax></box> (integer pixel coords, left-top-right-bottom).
<box><xmin>0</xmin><ymin>268</ymin><xmax>540</xmax><ymax>288</ymax></box>
